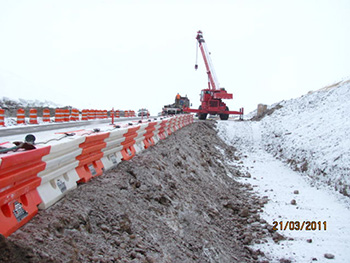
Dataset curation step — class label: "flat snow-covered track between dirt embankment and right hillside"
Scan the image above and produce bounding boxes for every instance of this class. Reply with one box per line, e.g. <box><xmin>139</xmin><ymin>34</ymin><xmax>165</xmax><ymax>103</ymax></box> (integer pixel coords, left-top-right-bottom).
<box><xmin>218</xmin><ymin>121</ymin><xmax>350</xmax><ymax>262</ymax></box>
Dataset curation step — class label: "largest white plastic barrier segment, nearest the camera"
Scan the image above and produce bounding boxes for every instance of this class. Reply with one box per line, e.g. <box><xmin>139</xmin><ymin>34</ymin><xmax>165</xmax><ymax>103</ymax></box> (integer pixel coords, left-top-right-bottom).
<box><xmin>37</xmin><ymin>137</ymin><xmax>85</xmax><ymax>209</ymax></box>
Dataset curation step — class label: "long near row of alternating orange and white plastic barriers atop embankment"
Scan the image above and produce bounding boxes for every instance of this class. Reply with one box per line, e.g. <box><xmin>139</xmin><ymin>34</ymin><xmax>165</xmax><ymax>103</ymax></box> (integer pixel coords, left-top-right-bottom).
<box><xmin>0</xmin><ymin>114</ymin><xmax>193</xmax><ymax>237</ymax></box>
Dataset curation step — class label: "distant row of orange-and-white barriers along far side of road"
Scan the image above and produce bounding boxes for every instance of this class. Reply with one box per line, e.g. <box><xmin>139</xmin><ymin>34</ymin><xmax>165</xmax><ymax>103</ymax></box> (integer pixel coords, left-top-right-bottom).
<box><xmin>0</xmin><ymin>108</ymin><xmax>136</xmax><ymax>127</ymax></box>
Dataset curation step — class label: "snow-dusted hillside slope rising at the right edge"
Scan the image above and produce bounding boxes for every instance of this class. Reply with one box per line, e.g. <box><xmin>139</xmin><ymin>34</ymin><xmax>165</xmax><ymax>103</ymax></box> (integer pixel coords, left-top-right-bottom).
<box><xmin>261</xmin><ymin>80</ymin><xmax>350</xmax><ymax>196</ymax></box>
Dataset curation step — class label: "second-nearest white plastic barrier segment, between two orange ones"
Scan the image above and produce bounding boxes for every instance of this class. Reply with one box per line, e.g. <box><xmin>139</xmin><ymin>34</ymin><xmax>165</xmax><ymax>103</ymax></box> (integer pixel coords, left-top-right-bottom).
<box><xmin>101</xmin><ymin>128</ymin><xmax>128</xmax><ymax>171</ymax></box>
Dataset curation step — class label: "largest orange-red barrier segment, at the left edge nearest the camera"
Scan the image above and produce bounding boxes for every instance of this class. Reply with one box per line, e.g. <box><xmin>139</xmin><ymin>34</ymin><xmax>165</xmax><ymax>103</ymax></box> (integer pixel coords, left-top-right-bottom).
<box><xmin>0</xmin><ymin>146</ymin><xmax>50</xmax><ymax>237</ymax></box>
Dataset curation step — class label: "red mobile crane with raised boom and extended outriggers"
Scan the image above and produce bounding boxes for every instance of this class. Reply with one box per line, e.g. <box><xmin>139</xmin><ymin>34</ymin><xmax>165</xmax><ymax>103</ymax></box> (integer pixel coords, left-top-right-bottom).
<box><xmin>184</xmin><ymin>31</ymin><xmax>243</xmax><ymax>120</ymax></box>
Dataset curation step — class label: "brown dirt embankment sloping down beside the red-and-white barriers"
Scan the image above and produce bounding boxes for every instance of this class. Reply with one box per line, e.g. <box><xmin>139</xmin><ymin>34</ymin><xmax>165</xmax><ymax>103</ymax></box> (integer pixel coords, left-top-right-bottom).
<box><xmin>0</xmin><ymin>121</ymin><xmax>279</xmax><ymax>263</ymax></box>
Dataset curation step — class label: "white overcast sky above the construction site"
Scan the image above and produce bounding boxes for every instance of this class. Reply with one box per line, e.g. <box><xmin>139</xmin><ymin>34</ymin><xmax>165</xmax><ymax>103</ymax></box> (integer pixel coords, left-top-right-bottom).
<box><xmin>0</xmin><ymin>0</ymin><xmax>350</xmax><ymax>114</ymax></box>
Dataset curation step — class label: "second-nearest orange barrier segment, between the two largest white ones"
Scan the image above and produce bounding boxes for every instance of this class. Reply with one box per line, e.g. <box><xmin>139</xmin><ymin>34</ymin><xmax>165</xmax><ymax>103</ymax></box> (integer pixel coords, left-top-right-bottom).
<box><xmin>75</xmin><ymin>132</ymin><xmax>109</xmax><ymax>183</ymax></box>
